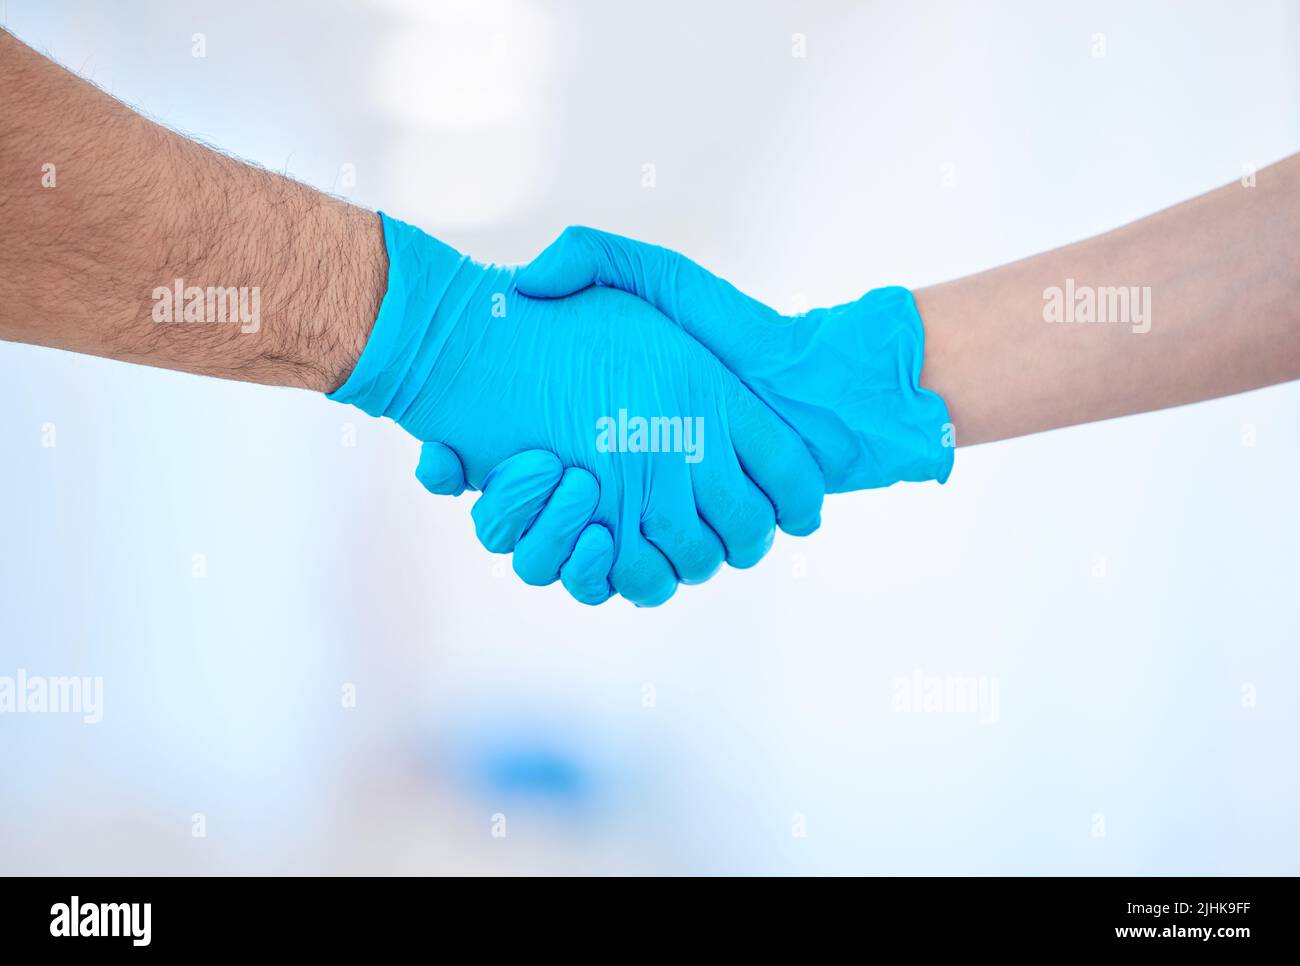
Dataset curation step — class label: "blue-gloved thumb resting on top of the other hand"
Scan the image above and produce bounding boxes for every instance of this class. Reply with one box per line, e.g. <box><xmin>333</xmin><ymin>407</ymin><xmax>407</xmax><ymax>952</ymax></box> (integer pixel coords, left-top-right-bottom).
<box><xmin>515</xmin><ymin>225</ymin><xmax>787</xmax><ymax>369</ymax></box>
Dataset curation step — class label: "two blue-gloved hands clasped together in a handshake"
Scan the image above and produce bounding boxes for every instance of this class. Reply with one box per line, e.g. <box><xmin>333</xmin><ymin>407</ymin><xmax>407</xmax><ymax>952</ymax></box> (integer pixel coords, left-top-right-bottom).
<box><xmin>329</xmin><ymin>213</ymin><xmax>953</xmax><ymax>606</ymax></box>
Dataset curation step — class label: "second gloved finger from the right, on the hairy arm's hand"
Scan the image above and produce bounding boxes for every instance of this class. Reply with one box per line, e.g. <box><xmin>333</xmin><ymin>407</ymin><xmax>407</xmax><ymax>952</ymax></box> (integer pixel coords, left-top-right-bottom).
<box><xmin>692</xmin><ymin>449</ymin><xmax>776</xmax><ymax>569</ymax></box>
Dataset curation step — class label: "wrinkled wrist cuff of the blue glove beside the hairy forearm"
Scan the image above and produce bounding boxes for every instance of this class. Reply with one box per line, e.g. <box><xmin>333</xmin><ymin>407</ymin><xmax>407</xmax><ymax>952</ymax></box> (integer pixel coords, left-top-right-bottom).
<box><xmin>326</xmin><ymin>212</ymin><xmax>482</xmax><ymax>420</ymax></box>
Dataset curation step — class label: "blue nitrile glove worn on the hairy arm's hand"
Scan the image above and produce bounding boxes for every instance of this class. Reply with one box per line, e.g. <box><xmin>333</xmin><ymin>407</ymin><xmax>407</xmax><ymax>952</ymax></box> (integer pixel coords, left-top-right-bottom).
<box><xmin>330</xmin><ymin>213</ymin><xmax>823</xmax><ymax>605</ymax></box>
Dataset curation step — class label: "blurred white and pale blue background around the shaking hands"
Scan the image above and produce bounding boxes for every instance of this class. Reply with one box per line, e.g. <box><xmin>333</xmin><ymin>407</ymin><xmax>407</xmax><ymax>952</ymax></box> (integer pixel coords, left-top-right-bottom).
<box><xmin>0</xmin><ymin>0</ymin><xmax>1300</xmax><ymax>875</ymax></box>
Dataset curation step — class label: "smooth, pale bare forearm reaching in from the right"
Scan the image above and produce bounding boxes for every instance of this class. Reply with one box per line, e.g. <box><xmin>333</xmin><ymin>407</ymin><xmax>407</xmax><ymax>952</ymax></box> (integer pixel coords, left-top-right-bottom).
<box><xmin>917</xmin><ymin>155</ymin><xmax>1300</xmax><ymax>445</ymax></box>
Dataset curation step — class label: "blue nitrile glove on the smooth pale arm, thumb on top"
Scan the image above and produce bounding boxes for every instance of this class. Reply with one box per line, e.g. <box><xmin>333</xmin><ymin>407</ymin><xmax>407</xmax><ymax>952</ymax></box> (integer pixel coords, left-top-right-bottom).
<box><xmin>516</xmin><ymin>228</ymin><xmax>954</xmax><ymax>493</ymax></box>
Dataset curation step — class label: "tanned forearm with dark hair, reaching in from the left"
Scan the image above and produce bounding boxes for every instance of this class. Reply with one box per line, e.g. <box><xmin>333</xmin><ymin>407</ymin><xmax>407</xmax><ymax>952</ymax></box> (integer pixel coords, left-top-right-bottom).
<box><xmin>0</xmin><ymin>31</ymin><xmax>387</xmax><ymax>390</ymax></box>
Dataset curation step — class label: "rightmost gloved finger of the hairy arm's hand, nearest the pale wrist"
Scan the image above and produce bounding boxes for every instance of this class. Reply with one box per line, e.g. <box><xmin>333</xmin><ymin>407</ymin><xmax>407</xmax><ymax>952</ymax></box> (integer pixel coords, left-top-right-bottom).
<box><xmin>725</xmin><ymin>377</ymin><xmax>826</xmax><ymax>537</ymax></box>
